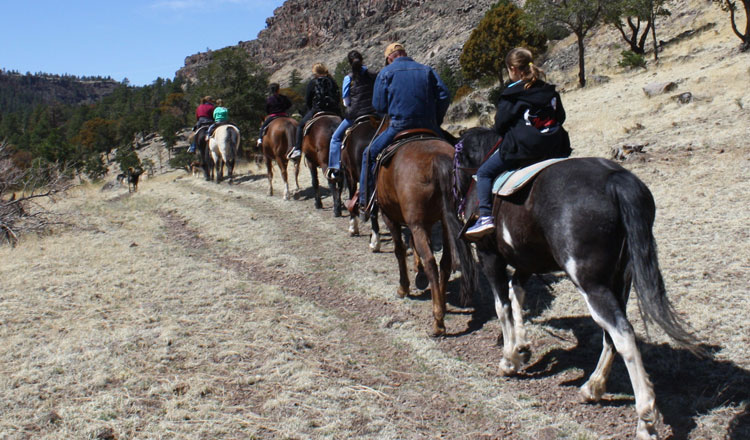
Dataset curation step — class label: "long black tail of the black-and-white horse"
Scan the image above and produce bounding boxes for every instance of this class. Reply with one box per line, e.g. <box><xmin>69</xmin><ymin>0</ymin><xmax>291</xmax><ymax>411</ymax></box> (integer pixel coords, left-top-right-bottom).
<box><xmin>607</xmin><ymin>171</ymin><xmax>706</xmax><ymax>355</ymax></box>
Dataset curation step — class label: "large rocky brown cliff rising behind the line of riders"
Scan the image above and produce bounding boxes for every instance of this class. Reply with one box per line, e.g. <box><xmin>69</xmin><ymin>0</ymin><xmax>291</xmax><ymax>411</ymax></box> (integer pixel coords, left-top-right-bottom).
<box><xmin>177</xmin><ymin>0</ymin><xmax>496</xmax><ymax>84</ymax></box>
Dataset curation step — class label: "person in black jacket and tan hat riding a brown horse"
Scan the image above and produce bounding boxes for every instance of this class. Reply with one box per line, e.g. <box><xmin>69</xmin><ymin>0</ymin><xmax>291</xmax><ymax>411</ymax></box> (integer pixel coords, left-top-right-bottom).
<box><xmin>287</xmin><ymin>63</ymin><xmax>340</xmax><ymax>160</ymax></box>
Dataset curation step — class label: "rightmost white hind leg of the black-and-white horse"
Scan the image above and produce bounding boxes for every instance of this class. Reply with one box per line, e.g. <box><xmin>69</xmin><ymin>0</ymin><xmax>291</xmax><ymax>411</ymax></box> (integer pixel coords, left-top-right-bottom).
<box><xmin>571</xmin><ymin>286</ymin><xmax>659</xmax><ymax>440</ymax></box>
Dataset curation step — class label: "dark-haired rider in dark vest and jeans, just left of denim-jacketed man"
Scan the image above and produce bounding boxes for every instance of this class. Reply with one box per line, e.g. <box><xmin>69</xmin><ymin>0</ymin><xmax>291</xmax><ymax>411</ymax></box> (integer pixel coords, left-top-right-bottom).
<box><xmin>326</xmin><ymin>50</ymin><xmax>377</xmax><ymax>180</ymax></box>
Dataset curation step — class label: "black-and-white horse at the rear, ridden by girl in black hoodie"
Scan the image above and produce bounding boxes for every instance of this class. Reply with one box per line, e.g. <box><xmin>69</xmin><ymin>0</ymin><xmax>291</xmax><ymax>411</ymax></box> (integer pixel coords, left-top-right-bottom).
<box><xmin>454</xmin><ymin>128</ymin><xmax>705</xmax><ymax>439</ymax></box>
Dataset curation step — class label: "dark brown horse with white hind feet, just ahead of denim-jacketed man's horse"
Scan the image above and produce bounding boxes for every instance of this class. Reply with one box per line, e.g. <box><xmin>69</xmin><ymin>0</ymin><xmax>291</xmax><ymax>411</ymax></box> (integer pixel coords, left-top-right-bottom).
<box><xmin>344</xmin><ymin>115</ymin><xmax>380</xmax><ymax>252</ymax></box>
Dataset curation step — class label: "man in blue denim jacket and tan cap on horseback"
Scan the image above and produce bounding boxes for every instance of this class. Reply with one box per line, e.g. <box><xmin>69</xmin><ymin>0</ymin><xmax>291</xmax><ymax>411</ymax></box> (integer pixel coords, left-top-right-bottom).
<box><xmin>359</xmin><ymin>43</ymin><xmax>450</xmax><ymax>217</ymax></box>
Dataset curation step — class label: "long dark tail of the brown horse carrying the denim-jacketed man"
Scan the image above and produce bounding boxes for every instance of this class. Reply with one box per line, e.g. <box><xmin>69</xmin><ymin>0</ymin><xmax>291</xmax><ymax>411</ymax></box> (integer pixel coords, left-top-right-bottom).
<box><xmin>433</xmin><ymin>151</ymin><xmax>478</xmax><ymax>305</ymax></box>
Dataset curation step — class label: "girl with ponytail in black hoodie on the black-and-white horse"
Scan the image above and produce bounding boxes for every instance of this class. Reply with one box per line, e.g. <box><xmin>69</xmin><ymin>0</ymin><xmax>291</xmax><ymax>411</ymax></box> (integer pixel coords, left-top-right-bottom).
<box><xmin>466</xmin><ymin>47</ymin><xmax>571</xmax><ymax>239</ymax></box>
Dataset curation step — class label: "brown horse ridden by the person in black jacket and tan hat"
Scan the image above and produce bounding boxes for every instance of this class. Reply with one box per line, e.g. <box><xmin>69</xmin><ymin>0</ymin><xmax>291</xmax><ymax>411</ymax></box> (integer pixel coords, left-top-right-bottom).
<box><xmin>302</xmin><ymin>113</ymin><xmax>342</xmax><ymax>213</ymax></box>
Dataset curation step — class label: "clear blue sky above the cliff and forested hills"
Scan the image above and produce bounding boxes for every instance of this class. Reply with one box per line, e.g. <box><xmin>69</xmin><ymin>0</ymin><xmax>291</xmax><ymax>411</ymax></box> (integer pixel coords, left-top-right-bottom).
<box><xmin>0</xmin><ymin>0</ymin><xmax>284</xmax><ymax>86</ymax></box>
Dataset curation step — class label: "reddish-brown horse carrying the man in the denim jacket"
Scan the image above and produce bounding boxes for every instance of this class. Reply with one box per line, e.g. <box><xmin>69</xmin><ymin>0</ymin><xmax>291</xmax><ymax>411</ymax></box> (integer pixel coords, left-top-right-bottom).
<box><xmin>375</xmin><ymin>135</ymin><xmax>477</xmax><ymax>336</ymax></box>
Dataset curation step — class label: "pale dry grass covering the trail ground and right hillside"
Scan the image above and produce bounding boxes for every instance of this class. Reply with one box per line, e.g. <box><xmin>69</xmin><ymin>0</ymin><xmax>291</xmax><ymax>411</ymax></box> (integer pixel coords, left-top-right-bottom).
<box><xmin>0</xmin><ymin>3</ymin><xmax>750</xmax><ymax>439</ymax></box>
